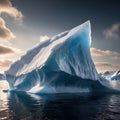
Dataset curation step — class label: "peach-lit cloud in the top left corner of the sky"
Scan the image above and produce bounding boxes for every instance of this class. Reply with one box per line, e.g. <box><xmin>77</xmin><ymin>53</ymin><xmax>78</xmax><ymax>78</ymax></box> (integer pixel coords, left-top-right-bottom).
<box><xmin>0</xmin><ymin>0</ymin><xmax>23</xmax><ymax>20</ymax></box>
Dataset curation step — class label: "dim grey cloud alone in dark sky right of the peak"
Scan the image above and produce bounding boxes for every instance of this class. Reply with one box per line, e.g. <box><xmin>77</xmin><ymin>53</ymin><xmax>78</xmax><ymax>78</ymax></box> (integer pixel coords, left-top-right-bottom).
<box><xmin>104</xmin><ymin>23</ymin><xmax>120</xmax><ymax>38</ymax></box>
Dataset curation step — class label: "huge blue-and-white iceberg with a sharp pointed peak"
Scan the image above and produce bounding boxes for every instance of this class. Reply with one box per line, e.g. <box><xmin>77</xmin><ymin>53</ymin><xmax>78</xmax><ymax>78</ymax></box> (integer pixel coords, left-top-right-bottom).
<box><xmin>5</xmin><ymin>21</ymin><xmax>99</xmax><ymax>92</ymax></box>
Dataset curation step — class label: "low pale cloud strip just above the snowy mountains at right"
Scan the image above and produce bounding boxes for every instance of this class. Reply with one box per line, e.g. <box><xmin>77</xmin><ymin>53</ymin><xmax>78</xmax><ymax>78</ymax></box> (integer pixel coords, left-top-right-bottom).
<box><xmin>95</xmin><ymin>62</ymin><xmax>120</xmax><ymax>72</ymax></box>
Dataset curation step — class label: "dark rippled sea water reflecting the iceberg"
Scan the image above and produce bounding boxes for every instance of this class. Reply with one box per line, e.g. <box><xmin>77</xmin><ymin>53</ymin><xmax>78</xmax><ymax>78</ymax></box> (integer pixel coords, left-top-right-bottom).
<box><xmin>0</xmin><ymin>82</ymin><xmax>120</xmax><ymax>120</ymax></box>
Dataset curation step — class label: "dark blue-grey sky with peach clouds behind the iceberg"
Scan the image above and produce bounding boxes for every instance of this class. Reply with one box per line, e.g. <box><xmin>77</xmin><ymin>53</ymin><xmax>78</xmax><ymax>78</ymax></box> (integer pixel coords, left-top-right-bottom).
<box><xmin>0</xmin><ymin>0</ymin><xmax>120</xmax><ymax>73</ymax></box>
